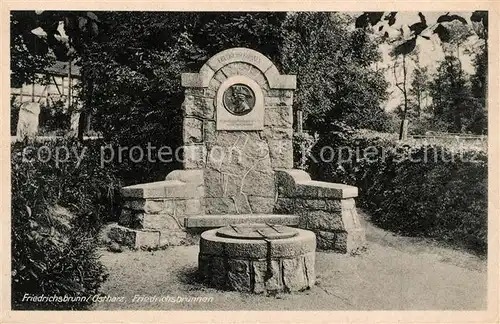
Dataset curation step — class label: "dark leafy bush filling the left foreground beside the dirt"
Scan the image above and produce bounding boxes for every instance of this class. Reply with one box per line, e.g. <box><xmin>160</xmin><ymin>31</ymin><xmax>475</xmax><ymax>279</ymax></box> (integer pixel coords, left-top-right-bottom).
<box><xmin>11</xmin><ymin>139</ymin><xmax>120</xmax><ymax>309</ymax></box>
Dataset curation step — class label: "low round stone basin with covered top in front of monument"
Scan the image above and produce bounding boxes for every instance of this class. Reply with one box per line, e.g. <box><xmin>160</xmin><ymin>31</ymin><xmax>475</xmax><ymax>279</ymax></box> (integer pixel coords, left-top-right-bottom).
<box><xmin>198</xmin><ymin>224</ymin><xmax>316</xmax><ymax>293</ymax></box>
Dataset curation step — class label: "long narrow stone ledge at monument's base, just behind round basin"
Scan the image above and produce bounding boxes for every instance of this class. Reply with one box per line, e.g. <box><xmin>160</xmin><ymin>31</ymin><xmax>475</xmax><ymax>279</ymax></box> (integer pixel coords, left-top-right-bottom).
<box><xmin>184</xmin><ymin>214</ymin><xmax>299</xmax><ymax>228</ymax></box>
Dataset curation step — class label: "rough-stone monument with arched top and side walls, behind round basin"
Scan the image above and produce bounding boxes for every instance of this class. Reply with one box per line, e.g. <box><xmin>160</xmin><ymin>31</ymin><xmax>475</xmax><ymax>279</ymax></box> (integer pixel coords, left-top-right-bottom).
<box><xmin>108</xmin><ymin>48</ymin><xmax>364</xmax><ymax>253</ymax></box>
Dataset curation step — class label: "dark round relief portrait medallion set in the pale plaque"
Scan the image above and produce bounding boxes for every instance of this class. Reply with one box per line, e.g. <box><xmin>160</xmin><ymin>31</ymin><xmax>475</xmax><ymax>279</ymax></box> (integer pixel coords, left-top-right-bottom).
<box><xmin>222</xmin><ymin>83</ymin><xmax>255</xmax><ymax>116</ymax></box>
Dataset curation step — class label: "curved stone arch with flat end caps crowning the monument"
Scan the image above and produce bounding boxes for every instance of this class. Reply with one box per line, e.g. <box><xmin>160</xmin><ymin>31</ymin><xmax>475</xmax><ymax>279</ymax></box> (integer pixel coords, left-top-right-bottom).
<box><xmin>181</xmin><ymin>47</ymin><xmax>297</xmax><ymax>89</ymax></box>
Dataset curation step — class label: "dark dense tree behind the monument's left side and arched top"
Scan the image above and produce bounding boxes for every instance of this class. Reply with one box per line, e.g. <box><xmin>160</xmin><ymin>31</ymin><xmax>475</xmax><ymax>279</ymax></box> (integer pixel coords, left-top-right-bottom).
<box><xmin>82</xmin><ymin>12</ymin><xmax>286</xmax><ymax>183</ymax></box>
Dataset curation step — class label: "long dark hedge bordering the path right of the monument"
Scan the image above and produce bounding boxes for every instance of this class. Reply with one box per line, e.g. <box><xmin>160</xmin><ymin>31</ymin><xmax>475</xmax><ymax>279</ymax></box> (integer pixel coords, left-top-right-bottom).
<box><xmin>311</xmin><ymin>130</ymin><xmax>488</xmax><ymax>254</ymax></box>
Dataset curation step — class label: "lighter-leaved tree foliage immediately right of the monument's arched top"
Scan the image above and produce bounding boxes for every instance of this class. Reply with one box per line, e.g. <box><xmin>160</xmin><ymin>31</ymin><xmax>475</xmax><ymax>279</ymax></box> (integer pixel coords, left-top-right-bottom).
<box><xmin>282</xmin><ymin>12</ymin><xmax>387</xmax><ymax>132</ymax></box>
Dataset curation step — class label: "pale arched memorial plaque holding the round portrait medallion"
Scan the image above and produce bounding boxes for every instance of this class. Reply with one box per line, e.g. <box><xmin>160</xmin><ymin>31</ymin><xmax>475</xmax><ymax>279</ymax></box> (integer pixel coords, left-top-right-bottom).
<box><xmin>217</xmin><ymin>76</ymin><xmax>264</xmax><ymax>130</ymax></box>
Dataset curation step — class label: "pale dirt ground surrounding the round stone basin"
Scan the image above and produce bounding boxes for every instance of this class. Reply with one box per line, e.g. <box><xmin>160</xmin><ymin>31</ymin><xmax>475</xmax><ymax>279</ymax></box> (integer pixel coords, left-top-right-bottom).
<box><xmin>93</xmin><ymin>214</ymin><xmax>487</xmax><ymax>310</ymax></box>
